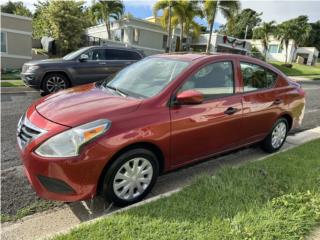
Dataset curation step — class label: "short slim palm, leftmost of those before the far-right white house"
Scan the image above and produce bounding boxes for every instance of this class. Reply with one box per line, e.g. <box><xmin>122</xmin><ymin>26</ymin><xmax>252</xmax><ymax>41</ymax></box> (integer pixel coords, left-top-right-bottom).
<box><xmin>253</xmin><ymin>21</ymin><xmax>276</xmax><ymax>60</ymax></box>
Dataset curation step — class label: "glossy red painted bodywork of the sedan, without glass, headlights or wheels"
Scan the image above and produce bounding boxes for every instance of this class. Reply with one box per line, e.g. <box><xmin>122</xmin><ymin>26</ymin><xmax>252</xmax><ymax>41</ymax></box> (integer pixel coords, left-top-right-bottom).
<box><xmin>20</xmin><ymin>54</ymin><xmax>305</xmax><ymax>201</ymax></box>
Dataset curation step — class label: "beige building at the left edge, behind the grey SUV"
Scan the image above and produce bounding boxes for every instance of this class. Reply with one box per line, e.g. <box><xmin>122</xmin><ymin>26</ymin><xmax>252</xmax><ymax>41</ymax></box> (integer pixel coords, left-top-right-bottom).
<box><xmin>1</xmin><ymin>13</ymin><xmax>32</xmax><ymax>69</ymax></box>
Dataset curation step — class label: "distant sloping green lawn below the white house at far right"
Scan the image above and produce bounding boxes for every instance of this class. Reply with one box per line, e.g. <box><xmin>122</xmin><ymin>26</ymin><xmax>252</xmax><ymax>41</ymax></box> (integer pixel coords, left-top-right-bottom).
<box><xmin>271</xmin><ymin>62</ymin><xmax>320</xmax><ymax>76</ymax></box>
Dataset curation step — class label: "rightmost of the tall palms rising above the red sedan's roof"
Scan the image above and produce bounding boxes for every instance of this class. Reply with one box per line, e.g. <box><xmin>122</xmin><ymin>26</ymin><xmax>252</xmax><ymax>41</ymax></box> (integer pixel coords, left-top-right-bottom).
<box><xmin>203</xmin><ymin>0</ymin><xmax>240</xmax><ymax>53</ymax></box>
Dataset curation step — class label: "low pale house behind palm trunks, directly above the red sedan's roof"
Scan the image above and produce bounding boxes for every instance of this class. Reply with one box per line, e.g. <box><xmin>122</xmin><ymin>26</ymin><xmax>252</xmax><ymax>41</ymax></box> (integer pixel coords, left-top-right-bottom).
<box><xmin>191</xmin><ymin>33</ymin><xmax>251</xmax><ymax>55</ymax></box>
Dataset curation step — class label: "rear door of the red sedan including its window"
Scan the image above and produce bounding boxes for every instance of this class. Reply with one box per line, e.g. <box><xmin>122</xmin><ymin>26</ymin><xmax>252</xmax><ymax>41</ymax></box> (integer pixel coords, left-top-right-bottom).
<box><xmin>239</xmin><ymin>60</ymin><xmax>284</xmax><ymax>142</ymax></box>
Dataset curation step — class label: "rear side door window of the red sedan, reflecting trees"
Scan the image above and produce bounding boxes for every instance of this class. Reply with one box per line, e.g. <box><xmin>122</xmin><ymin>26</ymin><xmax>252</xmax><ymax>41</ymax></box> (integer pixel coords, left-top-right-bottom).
<box><xmin>240</xmin><ymin>62</ymin><xmax>277</xmax><ymax>92</ymax></box>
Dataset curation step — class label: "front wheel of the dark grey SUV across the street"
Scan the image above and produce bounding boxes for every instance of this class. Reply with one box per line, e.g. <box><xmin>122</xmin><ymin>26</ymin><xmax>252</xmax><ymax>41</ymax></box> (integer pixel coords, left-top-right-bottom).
<box><xmin>42</xmin><ymin>73</ymin><xmax>70</xmax><ymax>95</ymax></box>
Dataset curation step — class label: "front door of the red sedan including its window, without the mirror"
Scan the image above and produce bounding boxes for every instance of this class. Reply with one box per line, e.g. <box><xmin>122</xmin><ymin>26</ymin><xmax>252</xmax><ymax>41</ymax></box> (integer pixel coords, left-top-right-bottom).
<box><xmin>170</xmin><ymin>61</ymin><xmax>242</xmax><ymax>167</ymax></box>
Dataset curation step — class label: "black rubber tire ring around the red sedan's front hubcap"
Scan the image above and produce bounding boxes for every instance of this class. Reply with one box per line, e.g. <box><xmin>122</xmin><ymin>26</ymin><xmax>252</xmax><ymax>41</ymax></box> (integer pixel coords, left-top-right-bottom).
<box><xmin>102</xmin><ymin>148</ymin><xmax>159</xmax><ymax>207</ymax></box>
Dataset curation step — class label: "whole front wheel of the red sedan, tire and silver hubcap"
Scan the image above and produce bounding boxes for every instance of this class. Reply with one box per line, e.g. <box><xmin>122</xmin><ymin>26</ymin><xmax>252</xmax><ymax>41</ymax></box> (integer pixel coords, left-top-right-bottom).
<box><xmin>103</xmin><ymin>148</ymin><xmax>159</xmax><ymax>207</ymax></box>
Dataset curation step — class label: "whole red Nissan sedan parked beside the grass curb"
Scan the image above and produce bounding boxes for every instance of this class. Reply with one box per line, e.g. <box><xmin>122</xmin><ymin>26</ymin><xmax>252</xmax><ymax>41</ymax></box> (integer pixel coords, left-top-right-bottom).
<box><xmin>17</xmin><ymin>54</ymin><xmax>305</xmax><ymax>206</ymax></box>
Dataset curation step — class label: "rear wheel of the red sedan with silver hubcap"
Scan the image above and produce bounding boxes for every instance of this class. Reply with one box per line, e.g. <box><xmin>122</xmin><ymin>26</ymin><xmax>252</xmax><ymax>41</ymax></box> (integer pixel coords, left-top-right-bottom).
<box><xmin>261</xmin><ymin>118</ymin><xmax>289</xmax><ymax>153</ymax></box>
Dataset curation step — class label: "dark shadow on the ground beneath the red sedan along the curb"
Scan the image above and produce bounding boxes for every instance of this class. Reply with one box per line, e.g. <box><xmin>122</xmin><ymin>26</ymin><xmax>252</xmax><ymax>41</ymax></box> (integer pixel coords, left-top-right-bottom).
<box><xmin>68</xmin><ymin>145</ymin><xmax>267</xmax><ymax>222</ymax></box>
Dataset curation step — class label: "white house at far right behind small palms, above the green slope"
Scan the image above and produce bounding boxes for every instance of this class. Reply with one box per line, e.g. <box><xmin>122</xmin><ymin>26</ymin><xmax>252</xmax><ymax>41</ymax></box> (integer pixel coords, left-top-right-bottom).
<box><xmin>248</xmin><ymin>36</ymin><xmax>319</xmax><ymax>65</ymax></box>
